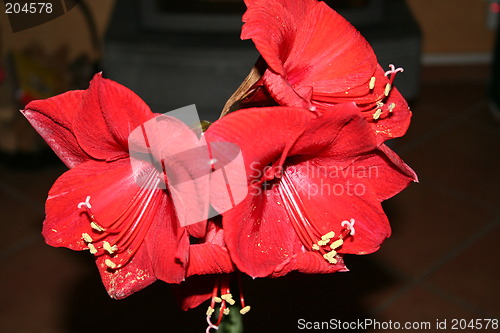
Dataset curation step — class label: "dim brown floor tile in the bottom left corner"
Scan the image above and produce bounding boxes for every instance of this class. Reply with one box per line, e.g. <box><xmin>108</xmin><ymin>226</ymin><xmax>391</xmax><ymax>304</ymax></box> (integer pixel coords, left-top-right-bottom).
<box><xmin>0</xmin><ymin>241</ymin><xmax>87</xmax><ymax>332</ymax></box>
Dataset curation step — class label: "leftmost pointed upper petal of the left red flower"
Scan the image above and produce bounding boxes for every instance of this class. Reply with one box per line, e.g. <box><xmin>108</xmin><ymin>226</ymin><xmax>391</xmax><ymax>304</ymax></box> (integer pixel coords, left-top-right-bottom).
<box><xmin>21</xmin><ymin>90</ymin><xmax>89</xmax><ymax>168</ymax></box>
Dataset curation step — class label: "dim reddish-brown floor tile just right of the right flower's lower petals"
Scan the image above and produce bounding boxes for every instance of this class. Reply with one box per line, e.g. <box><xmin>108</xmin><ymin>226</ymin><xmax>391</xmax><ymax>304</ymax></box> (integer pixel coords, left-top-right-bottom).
<box><xmin>378</xmin><ymin>182</ymin><xmax>494</xmax><ymax>277</ymax></box>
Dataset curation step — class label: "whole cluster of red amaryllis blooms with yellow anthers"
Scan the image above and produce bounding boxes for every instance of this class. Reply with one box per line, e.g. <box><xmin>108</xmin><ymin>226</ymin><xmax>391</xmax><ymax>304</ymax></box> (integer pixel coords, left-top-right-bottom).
<box><xmin>22</xmin><ymin>0</ymin><xmax>416</xmax><ymax>329</ymax></box>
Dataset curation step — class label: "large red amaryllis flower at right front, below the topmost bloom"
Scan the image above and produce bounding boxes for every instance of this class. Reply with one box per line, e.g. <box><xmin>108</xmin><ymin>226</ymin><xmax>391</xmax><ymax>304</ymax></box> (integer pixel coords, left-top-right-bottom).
<box><xmin>206</xmin><ymin>103</ymin><xmax>416</xmax><ymax>277</ymax></box>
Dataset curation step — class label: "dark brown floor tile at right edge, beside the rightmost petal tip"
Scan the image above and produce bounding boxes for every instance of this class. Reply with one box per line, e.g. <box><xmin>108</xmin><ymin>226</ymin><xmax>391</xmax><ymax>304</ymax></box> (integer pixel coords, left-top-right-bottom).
<box><xmin>402</xmin><ymin>113</ymin><xmax>500</xmax><ymax>209</ymax></box>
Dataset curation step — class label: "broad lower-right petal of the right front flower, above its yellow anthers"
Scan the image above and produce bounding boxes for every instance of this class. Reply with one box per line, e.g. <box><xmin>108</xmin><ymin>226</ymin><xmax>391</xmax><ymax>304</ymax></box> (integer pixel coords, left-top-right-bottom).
<box><xmin>286</xmin><ymin>159</ymin><xmax>390</xmax><ymax>254</ymax></box>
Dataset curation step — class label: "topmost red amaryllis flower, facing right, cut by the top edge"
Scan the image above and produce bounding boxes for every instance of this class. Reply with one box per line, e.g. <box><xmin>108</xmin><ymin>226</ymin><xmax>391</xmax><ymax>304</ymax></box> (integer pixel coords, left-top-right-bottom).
<box><xmin>241</xmin><ymin>0</ymin><xmax>411</xmax><ymax>141</ymax></box>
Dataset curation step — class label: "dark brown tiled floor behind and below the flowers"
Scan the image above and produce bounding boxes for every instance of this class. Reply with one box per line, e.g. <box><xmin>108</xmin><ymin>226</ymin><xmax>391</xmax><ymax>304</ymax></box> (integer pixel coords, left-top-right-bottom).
<box><xmin>0</xmin><ymin>63</ymin><xmax>500</xmax><ymax>333</ymax></box>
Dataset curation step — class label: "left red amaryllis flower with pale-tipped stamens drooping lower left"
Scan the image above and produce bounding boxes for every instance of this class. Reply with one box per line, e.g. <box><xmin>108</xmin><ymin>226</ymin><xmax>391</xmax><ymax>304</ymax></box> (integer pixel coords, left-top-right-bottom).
<box><xmin>22</xmin><ymin>74</ymin><xmax>208</xmax><ymax>298</ymax></box>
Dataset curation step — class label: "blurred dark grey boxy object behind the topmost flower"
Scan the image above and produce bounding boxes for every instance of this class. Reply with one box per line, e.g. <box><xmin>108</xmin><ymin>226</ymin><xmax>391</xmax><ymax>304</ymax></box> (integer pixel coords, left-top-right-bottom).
<box><xmin>103</xmin><ymin>0</ymin><xmax>421</xmax><ymax>121</ymax></box>
